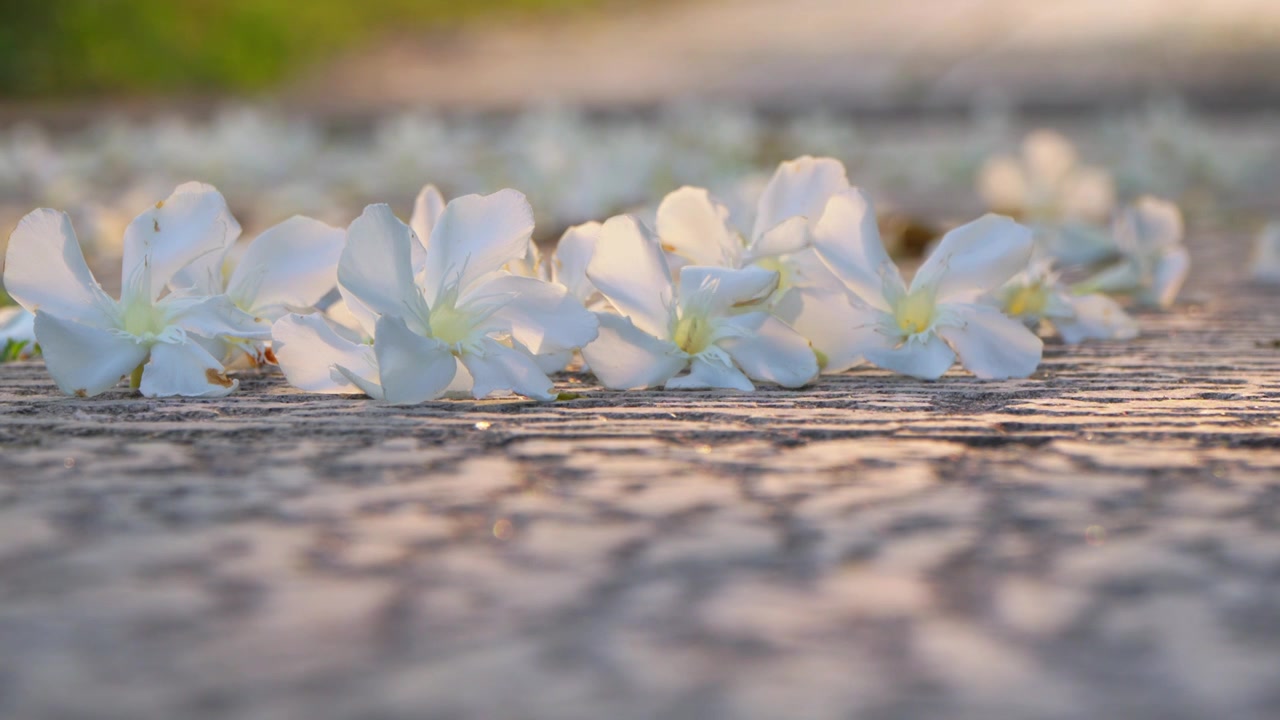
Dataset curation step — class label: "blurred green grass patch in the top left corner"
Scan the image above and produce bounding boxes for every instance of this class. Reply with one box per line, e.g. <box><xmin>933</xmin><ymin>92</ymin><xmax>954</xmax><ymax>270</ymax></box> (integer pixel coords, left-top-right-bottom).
<box><xmin>0</xmin><ymin>0</ymin><xmax>602</xmax><ymax>97</ymax></box>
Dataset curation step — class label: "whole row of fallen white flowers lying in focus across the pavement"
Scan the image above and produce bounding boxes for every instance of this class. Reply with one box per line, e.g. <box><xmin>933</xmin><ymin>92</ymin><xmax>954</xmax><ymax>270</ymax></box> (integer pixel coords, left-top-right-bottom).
<box><xmin>4</xmin><ymin>151</ymin><xmax>1187</xmax><ymax>404</ymax></box>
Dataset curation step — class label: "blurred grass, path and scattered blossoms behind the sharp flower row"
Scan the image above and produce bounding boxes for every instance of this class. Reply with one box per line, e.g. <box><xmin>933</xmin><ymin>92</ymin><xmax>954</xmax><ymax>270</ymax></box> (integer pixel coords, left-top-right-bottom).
<box><xmin>0</xmin><ymin>0</ymin><xmax>1280</xmax><ymax>271</ymax></box>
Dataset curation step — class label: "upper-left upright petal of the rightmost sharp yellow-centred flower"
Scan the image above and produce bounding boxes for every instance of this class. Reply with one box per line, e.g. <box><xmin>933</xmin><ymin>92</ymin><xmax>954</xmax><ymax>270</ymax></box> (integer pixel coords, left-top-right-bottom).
<box><xmin>813</xmin><ymin>188</ymin><xmax>897</xmax><ymax>309</ymax></box>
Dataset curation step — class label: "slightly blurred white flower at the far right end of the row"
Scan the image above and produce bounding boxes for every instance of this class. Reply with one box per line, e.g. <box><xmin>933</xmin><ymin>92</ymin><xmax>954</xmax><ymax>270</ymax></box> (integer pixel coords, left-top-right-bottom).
<box><xmin>1076</xmin><ymin>196</ymin><xmax>1190</xmax><ymax>309</ymax></box>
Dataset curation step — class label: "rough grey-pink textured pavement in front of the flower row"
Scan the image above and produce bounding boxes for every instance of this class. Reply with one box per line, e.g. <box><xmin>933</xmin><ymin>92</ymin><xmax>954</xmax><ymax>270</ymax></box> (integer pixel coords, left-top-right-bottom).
<box><xmin>0</xmin><ymin>226</ymin><xmax>1280</xmax><ymax>720</ymax></box>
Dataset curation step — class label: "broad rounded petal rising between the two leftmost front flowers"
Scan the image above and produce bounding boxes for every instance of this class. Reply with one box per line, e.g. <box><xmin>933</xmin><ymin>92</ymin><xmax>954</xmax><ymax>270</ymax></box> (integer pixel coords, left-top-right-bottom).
<box><xmin>227</xmin><ymin>215</ymin><xmax>346</xmax><ymax>320</ymax></box>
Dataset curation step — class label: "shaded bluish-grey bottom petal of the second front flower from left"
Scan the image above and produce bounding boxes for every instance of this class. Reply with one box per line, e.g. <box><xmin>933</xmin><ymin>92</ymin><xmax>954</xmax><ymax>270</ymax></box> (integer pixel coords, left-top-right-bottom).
<box><xmin>374</xmin><ymin>315</ymin><xmax>457</xmax><ymax>405</ymax></box>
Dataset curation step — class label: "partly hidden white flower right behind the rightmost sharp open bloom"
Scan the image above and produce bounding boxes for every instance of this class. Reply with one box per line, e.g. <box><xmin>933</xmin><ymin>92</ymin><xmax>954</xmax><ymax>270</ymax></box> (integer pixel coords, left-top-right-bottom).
<box><xmin>993</xmin><ymin>258</ymin><xmax>1138</xmax><ymax>345</ymax></box>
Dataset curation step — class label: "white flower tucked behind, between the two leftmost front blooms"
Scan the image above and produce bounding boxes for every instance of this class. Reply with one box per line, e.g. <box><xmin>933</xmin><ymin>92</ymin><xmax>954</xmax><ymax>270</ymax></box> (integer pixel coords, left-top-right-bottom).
<box><xmin>169</xmin><ymin>210</ymin><xmax>346</xmax><ymax>363</ymax></box>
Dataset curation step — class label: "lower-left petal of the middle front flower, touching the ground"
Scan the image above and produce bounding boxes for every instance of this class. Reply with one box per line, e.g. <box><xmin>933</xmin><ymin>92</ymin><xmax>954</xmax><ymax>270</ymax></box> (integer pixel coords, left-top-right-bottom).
<box><xmin>582</xmin><ymin>313</ymin><xmax>689</xmax><ymax>389</ymax></box>
